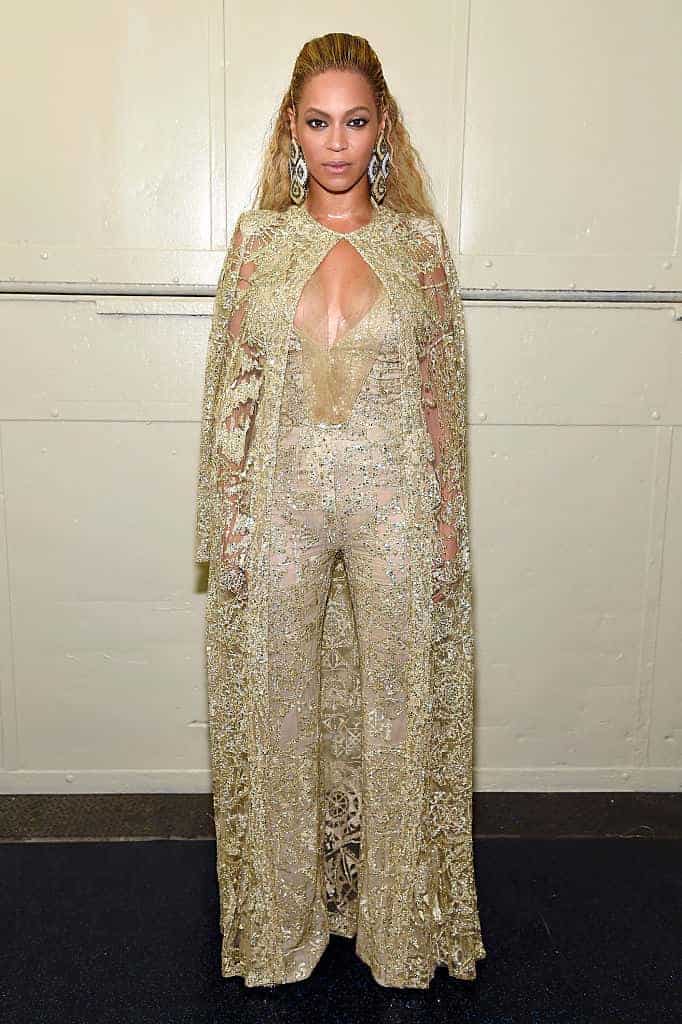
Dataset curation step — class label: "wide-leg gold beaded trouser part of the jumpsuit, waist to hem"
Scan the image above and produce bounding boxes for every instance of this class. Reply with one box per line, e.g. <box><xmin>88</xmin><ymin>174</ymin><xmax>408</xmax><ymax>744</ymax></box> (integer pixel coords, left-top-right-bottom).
<box><xmin>267</xmin><ymin>424</ymin><xmax>409</xmax><ymax>980</ymax></box>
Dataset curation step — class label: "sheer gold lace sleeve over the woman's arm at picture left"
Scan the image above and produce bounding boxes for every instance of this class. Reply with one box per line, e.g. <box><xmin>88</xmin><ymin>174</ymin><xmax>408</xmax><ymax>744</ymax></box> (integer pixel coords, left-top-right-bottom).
<box><xmin>195</xmin><ymin>214</ymin><xmax>262</xmax><ymax>590</ymax></box>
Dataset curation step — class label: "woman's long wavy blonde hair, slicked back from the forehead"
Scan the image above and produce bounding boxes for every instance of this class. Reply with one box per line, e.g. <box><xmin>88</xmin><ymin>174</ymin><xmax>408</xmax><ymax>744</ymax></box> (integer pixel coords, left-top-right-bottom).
<box><xmin>252</xmin><ymin>32</ymin><xmax>435</xmax><ymax>216</ymax></box>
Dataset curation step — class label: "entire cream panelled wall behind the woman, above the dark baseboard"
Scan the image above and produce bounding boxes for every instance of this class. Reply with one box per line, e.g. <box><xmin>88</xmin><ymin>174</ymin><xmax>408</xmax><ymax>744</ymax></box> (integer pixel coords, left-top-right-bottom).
<box><xmin>0</xmin><ymin>0</ymin><xmax>682</xmax><ymax>793</ymax></box>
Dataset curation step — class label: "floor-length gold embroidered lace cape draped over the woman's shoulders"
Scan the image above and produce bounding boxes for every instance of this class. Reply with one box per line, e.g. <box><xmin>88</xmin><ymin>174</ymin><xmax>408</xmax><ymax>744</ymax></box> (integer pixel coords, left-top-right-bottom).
<box><xmin>195</xmin><ymin>205</ymin><xmax>485</xmax><ymax>987</ymax></box>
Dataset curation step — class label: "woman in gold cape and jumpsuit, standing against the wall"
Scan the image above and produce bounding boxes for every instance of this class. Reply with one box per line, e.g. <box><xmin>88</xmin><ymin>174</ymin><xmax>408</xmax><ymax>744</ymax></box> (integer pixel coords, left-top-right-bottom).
<box><xmin>196</xmin><ymin>33</ymin><xmax>485</xmax><ymax>988</ymax></box>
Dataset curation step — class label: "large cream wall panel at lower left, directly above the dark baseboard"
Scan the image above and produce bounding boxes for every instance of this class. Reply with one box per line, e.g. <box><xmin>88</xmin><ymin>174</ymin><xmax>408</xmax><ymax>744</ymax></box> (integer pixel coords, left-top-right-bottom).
<box><xmin>4</xmin><ymin>422</ymin><xmax>207</xmax><ymax>788</ymax></box>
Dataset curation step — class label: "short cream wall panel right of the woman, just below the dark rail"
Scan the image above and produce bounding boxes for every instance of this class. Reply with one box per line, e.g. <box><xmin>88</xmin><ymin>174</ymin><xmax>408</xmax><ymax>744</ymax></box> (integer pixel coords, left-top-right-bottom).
<box><xmin>467</xmin><ymin>302</ymin><xmax>682</xmax><ymax>425</ymax></box>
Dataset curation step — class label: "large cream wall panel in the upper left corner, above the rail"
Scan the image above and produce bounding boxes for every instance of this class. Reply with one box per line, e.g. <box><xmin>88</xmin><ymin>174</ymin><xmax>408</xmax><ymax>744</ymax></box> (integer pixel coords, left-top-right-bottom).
<box><xmin>0</xmin><ymin>0</ymin><xmax>226</xmax><ymax>285</ymax></box>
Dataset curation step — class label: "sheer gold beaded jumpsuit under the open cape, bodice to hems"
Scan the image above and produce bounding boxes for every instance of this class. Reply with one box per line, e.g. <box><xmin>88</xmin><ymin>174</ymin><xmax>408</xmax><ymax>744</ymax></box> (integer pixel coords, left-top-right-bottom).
<box><xmin>268</xmin><ymin>260</ymin><xmax>421</xmax><ymax>973</ymax></box>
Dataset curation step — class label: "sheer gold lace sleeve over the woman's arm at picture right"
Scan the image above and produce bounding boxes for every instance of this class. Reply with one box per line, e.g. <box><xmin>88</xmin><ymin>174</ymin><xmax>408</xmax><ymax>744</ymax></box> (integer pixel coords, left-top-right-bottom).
<box><xmin>418</xmin><ymin>221</ymin><xmax>469</xmax><ymax>593</ymax></box>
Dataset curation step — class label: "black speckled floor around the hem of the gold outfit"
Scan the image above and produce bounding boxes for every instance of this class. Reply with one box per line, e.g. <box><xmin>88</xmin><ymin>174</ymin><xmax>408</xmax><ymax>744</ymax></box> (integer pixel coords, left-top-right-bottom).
<box><xmin>0</xmin><ymin>839</ymin><xmax>682</xmax><ymax>1024</ymax></box>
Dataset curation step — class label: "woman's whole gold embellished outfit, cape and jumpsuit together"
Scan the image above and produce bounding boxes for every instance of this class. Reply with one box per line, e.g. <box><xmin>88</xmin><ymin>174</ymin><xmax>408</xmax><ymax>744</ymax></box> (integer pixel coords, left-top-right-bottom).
<box><xmin>193</xmin><ymin>203</ymin><xmax>485</xmax><ymax>987</ymax></box>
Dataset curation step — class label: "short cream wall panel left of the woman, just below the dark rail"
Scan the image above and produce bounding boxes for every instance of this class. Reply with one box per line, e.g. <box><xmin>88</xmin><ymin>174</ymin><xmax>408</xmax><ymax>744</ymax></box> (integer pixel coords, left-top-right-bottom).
<box><xmin>0</xmin><ymin>296</ymin><xmax>212</xmax><ymax>420</ymax></box>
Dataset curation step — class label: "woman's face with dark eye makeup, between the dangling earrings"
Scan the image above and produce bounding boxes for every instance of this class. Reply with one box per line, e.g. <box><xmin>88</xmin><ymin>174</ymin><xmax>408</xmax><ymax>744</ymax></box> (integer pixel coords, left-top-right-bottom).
<box><xmin>289</xmin><ymin>69</ymin><xmax>384</xmax><ymax>194</ymax></box>
